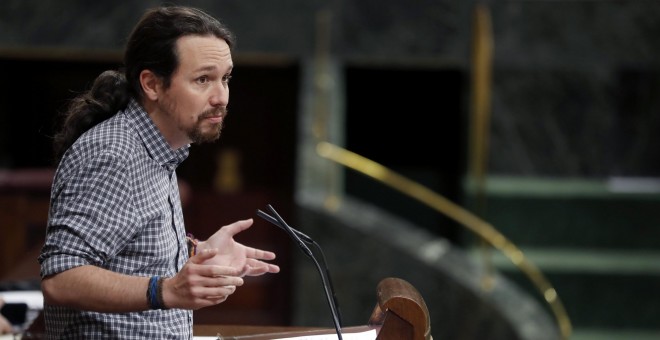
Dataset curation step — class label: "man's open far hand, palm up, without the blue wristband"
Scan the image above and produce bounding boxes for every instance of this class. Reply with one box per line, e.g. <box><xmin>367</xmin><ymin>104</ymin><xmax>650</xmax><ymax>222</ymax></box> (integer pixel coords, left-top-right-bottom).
<box><xmin>197</xmin><ymin>218</ymin><xmax>280</xmax><ymax>276</ymax></box>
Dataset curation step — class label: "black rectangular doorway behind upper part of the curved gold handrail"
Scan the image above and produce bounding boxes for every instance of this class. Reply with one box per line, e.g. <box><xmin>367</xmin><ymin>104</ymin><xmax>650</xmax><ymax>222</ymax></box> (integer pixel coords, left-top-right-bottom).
<box><xmin>345</xmin><ymin>66</ymin><xmax>466</xmax><ymax>242</ymax></box>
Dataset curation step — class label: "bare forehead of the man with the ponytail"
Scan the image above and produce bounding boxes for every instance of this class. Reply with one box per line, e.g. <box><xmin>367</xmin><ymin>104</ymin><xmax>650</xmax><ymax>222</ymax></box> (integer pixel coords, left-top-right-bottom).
<box><xmin>176</xmin><ymin>35</ymin><xmax>233</xmax><ymax>70</ymax></box>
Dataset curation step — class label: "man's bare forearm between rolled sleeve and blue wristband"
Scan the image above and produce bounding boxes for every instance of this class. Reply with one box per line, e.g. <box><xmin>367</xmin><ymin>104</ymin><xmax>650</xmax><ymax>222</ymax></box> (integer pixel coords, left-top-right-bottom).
<box><xmin>41</xmin><ymin>265</ymin><xmax>149</xmax><ymax>312</ymax></box>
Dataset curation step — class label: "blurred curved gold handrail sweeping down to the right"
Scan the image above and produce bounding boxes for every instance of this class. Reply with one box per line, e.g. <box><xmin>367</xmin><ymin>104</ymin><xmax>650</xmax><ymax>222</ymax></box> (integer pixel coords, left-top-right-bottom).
<box><xmin>316</xmin><ymin>142</ymin><xmax>572</xmax><ymax>339</ymax></box>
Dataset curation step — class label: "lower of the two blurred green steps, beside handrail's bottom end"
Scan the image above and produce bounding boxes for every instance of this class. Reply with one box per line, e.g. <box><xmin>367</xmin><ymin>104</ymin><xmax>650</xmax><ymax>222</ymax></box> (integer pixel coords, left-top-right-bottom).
<box><xmin>470</xmin><ymin>247</ymin><xmax>660</xmax><ymax>332</ymax></box>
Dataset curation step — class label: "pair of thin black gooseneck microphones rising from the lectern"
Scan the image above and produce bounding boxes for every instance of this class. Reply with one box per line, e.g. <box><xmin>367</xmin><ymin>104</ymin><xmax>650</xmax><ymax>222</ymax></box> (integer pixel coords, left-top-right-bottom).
<box><xmin>257</xmin><ymin>204</ymin><xmax>343</xmax><ymax>340</ymax></box>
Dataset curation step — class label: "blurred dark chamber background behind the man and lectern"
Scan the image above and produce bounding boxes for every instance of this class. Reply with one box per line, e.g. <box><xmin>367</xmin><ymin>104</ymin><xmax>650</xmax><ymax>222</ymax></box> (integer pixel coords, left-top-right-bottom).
<box><xmin>0</xmin><ymin>0</ymin><xmax>660</xmax><ymax>339</ymax></box>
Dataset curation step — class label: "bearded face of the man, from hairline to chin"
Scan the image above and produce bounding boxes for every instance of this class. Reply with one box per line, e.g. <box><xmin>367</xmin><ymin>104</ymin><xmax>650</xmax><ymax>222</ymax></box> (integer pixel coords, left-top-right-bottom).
<box><xmin>156</xmin><ymin>36</ymin><xmax>233</xmax><ymax>147</ymax></box>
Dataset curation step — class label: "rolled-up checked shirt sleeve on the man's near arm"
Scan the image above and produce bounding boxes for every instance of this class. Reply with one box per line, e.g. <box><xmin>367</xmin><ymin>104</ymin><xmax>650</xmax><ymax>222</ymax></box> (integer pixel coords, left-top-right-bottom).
<box><xmin>39</xmin><ymin>153</ymin><xmax>135</xmax><ymax>277</ymax></box>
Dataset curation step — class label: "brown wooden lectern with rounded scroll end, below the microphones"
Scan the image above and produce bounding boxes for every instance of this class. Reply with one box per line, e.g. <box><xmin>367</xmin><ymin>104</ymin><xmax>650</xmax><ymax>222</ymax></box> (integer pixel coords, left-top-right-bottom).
<box><xmin>23</xmin><ymin>278</ymin><xmax>432</xmax><ymax>340</ymax></box>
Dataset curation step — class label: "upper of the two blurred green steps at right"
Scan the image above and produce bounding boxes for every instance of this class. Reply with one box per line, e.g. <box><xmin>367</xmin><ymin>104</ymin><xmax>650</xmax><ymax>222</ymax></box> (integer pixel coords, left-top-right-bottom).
<box><xmin>465</xmin><ymin>177</ymin><xmax>660</xmax><ymax>250</ymax></box>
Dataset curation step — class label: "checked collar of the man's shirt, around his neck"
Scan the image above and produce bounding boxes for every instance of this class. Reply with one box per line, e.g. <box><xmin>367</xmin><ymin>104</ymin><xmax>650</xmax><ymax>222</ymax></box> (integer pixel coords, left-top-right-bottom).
<box><xmin>125</xmin><ymin>98</ymin><xmax>190</xmax><ymax>171</ymax></box>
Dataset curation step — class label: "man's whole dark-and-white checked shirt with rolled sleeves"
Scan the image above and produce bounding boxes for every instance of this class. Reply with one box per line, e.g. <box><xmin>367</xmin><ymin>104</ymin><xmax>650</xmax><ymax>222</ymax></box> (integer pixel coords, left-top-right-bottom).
<box><xmin>39</xmin><ymin>100</ymin><xmax>192</xmax><ymax>339</ymax></box>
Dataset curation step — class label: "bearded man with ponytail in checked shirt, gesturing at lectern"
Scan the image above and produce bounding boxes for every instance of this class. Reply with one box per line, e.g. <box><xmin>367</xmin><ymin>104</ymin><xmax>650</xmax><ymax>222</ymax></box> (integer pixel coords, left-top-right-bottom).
<box><xmin>39</xmin><ymin>6</ymin><xmax>279</xmax><ymax>339</ymax></box>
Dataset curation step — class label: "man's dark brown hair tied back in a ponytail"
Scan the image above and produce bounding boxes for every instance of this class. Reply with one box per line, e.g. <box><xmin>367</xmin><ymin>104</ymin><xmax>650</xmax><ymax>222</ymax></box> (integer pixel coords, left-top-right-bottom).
<box><xmin>53</xmin><ymin>6</ymin><xmax>234</xmax><ymax>162</ymax></box>
